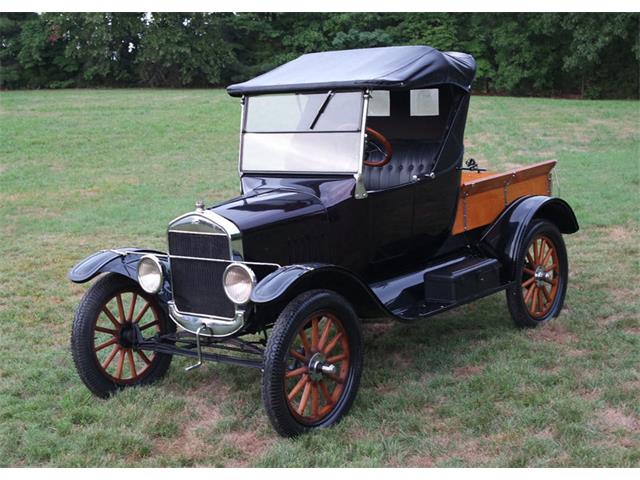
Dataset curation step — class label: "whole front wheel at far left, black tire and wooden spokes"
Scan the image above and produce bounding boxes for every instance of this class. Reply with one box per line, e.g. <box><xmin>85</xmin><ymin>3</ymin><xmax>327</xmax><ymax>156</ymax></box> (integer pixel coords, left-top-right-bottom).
<box><xmin>71</xmin><ymin>274</ymin><xmax>175</xmax><ymax>397</ymax></box>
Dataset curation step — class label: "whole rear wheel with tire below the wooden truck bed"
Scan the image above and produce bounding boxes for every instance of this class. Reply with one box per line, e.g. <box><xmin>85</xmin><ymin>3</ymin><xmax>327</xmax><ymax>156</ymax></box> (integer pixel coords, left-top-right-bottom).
<box><xmin>507</xmin><ymin>220</ymin><xmax>568</xmax><ymax>327</ymax></box>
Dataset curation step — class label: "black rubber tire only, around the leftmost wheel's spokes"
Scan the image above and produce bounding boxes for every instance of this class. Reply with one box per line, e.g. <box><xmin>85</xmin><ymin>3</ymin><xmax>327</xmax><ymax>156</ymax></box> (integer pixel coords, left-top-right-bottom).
<box><xmin>71</xmin><ymin>273</ymin><xmax>175</xmax><ymax>398</ymax></box>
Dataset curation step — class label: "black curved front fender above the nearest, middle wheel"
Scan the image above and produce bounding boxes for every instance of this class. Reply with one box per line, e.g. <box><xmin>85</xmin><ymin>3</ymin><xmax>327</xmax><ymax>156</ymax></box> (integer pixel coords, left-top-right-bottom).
<box><xmin>251</xmin><ymin>263</ymin><xmax>391</xmax><ymax>317</ymax></box>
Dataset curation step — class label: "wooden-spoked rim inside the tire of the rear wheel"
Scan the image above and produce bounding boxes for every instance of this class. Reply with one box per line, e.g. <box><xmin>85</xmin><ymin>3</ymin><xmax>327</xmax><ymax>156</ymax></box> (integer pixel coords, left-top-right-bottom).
<box><xmin>522</xmin><ymin>235</ymin><xmax>560</xmax><ymax>318</ymax></box>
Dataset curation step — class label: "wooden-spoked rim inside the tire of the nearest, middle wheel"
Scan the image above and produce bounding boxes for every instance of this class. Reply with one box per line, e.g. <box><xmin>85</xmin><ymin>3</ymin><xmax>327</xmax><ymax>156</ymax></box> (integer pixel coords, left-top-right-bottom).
<box><xmin>284</xmin><ymin>311</ymin><xmax>350</xmax><ymax>424</ymax></box>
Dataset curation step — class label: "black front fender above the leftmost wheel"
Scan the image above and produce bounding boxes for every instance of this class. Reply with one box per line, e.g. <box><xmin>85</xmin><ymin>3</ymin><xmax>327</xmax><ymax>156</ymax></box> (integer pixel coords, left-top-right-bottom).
<box><xmin>68</xmin><ymin>248</ymin><xmax>168</xmax><ymax>283</ymax></box>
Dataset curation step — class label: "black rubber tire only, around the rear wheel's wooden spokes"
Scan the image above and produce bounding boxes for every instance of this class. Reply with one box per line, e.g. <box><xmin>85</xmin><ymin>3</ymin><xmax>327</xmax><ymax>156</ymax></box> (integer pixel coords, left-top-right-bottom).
<box><xmin>506</xmin><ymin>219</ymin><xmax>569</xmax><ymax>328</ymax></box>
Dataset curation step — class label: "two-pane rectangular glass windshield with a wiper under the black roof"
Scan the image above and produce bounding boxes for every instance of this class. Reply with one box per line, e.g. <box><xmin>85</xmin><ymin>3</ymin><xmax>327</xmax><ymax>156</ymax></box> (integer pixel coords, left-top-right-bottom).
<box><xmin>241</xmin><ymin>92</ymin><xmax>363</xmax><ymax>173</ymax></box>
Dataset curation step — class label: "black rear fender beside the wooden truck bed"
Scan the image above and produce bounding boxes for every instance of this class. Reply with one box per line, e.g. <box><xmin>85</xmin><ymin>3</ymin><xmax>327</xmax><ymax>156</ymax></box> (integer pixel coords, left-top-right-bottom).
<box><xmin>480</xmin><ymin>195</ymin><xmax>580</xmax><ymax>279</ymax></box>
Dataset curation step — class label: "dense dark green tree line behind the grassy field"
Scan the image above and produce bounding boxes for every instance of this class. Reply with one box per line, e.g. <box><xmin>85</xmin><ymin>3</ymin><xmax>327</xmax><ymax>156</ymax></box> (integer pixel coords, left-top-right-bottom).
<box><xmin>0</xmin><ymin>12</ymin><xmax>640</xmax><ymax>98</ymax></box>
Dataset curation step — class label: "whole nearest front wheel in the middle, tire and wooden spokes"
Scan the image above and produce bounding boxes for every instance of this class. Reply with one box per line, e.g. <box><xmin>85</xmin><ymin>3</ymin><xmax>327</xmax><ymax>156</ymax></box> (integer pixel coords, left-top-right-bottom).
<box><xmin>262</xmin><ymin>290</ymin><xmax>362</xmax><ymax>437</ymax></box>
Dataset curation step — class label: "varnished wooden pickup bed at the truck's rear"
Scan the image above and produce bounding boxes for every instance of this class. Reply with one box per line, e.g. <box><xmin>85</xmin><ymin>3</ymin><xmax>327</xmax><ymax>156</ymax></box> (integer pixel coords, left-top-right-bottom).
<box><xmin>452</xmin><ymin>160</ymin><xmax>556</xmax><ymax>235</ymax></box>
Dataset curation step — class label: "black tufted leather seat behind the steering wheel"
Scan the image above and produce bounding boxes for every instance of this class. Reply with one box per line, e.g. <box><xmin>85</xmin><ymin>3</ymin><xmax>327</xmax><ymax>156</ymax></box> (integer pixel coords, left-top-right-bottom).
<box><xmin>363</xmin><ymin>140</ymin><xmax>440</xmax><ymax>190</ymax></box>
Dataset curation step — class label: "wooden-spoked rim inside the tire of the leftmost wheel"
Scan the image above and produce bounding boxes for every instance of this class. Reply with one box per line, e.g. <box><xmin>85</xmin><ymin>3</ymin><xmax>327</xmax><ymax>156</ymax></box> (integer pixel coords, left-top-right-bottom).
<box><xmin>93</xmin><ymin>291</ymin><xmax>160</xmax><ymax>384</ymax></box>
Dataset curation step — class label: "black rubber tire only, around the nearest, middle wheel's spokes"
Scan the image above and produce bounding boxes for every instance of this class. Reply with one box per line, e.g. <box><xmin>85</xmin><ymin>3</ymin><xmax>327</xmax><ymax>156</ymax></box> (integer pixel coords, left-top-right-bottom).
<box><xmin>262</xmin><ymin>290</ymin><xmax>363</xmax><ymax>437</ymax></box>
